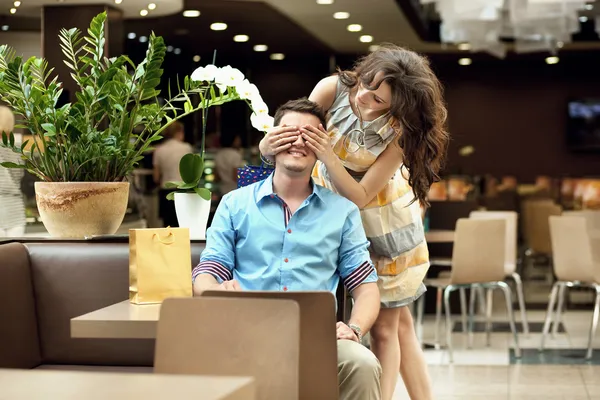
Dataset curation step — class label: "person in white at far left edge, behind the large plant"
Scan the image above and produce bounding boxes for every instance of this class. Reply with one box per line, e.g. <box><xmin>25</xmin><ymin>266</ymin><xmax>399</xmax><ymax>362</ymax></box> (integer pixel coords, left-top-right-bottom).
<box><xmin>0</xmin><ymin>106</ymin><xmax>27</xmax><ymax>237</ymax></box>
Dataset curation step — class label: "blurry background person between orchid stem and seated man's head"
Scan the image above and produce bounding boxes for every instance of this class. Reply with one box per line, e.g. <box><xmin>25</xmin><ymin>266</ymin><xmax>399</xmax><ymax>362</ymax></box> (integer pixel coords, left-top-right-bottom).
<box><xmin>215</xmin><ymin>135</ymin><xmax>244</xmax><ymax>195</ymax></box>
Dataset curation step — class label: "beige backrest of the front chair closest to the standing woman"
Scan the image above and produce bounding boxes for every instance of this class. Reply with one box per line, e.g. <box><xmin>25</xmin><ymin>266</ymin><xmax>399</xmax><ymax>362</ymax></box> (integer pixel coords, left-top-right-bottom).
<box><xmin>451</xmin><ymin>218</ymin><xmax>506</xmax><ymax>284</ymax></box>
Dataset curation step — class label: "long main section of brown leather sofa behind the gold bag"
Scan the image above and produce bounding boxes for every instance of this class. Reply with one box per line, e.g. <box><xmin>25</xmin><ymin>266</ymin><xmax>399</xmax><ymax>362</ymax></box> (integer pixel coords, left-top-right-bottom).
<box><xmin>26</xmin><ymin>242</ymin><xmax>204</xmax><ymax>366</ymax></box>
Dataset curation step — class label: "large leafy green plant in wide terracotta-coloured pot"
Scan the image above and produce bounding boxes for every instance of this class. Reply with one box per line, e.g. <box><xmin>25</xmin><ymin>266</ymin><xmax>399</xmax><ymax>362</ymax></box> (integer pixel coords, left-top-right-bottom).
<box><xmin>0</xmin><ymin>12</ymin><xmax>272</xmax><ymax>238</ymax></box>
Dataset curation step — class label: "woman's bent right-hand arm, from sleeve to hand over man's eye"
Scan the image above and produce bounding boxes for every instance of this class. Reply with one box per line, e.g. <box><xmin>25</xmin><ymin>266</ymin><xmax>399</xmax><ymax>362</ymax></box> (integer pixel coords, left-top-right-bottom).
<box><xmin>301</xmin><ymin>125</ymin><xmax>403</xmax><ymax>209</ymax></box>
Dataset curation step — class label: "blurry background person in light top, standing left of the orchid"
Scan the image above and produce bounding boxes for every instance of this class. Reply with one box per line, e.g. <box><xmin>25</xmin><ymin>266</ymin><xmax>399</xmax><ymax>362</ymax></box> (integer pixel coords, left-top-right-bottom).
<box><xmin>152</xmin><ymin>121</ymin><xmax>194</xmax><ymax>227</ymax></box>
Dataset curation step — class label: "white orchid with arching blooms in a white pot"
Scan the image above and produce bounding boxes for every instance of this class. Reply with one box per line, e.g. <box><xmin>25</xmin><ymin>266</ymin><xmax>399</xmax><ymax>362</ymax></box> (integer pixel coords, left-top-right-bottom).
<box><xmin>166</xmin><ymin>64</ymin><xmax>273</xmax><ymax>239</ymax></box>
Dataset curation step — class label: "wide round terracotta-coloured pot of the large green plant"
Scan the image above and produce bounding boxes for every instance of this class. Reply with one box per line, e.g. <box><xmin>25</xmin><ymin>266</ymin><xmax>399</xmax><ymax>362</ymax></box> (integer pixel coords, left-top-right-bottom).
<box><xmin>35</xmin><ymin>182</ymin><xmax>129</xmax><ymax>238</ymax></box>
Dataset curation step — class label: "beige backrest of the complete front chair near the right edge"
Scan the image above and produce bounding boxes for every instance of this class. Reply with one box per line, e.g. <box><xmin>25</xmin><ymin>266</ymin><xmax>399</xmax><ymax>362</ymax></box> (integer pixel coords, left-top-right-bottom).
<box><xmin>550</xmin><ymin>215</ymin><xmax>595</xmax><ymax>282</ymax></box>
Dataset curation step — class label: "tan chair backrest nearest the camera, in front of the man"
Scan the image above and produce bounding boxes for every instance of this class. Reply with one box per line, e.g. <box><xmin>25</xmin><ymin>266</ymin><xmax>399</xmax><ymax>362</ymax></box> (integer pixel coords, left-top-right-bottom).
<box><xmin>154</xmin><ymin>297</ymin><xmax>300</xmax><ymax>400</ymax></box>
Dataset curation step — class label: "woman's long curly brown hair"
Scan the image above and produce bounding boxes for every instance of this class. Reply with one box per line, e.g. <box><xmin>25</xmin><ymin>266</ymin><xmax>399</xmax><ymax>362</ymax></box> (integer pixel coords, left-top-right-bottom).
<box><xmin>339</xmin><ymin>44</ymin><xmax>449</xmax><ymax>206</ymax></box>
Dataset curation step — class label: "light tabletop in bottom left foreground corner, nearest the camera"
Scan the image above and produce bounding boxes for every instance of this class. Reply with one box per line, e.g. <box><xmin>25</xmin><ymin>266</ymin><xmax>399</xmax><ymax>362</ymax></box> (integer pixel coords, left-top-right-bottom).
<box><xmin>0</xmin><ymin>369</ymin><xmax>256</xmax><ymax>400</ymax></box>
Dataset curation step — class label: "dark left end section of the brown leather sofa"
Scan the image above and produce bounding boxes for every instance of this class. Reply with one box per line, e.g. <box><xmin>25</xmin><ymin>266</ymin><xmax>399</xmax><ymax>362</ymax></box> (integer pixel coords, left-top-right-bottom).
<box><xmin>0</xmin><ymin>243</ymin><xmax>41</xmax><ymax>368</ymax></box>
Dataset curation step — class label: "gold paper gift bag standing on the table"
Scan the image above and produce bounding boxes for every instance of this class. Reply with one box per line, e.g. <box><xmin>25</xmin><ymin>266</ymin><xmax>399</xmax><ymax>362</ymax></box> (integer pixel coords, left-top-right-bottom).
<box><xmin>129</xmin><ymin>228</ymin><xmax>192</xmax><ymax>304</ymax></box>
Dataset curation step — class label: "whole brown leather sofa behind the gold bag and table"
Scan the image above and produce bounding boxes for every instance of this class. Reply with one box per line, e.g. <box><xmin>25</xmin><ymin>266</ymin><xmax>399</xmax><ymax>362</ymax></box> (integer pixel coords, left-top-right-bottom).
<box><xmin>0</xmin><ymin>239</ymin><xmax>204</xmax><ymax>368</ymax></box>
